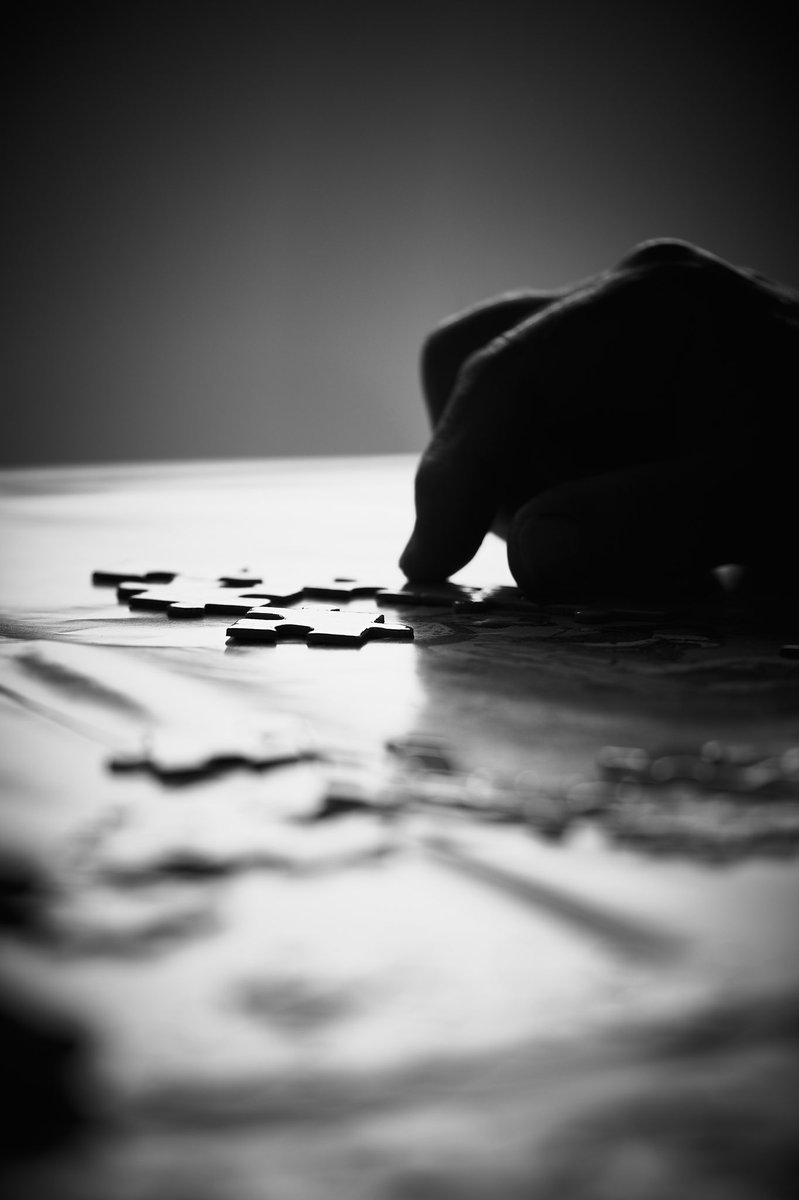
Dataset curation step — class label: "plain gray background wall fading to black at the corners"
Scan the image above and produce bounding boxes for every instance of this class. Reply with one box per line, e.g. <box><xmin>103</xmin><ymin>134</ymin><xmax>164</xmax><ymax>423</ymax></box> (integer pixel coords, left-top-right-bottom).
<box><xmin>6</xmin><ymin>0</ymin><xmax>799</xmax><ymax>463</ymax></box>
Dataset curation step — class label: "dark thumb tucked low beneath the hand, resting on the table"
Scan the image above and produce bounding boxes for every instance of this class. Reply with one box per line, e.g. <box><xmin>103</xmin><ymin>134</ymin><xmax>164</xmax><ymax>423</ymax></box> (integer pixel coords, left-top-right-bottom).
<box><xmin>507</xmin><ymin>455</ymin><xmax>752</xmax><ymax>599</ymax></box>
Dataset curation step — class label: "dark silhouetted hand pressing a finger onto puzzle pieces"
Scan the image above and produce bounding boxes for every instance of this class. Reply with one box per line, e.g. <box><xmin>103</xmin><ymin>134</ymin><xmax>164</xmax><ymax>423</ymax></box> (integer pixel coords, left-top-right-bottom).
<box><xmin>400</xmin><ymin>240</ymin><xmax>799</xmax><ymax>598</ymax></box>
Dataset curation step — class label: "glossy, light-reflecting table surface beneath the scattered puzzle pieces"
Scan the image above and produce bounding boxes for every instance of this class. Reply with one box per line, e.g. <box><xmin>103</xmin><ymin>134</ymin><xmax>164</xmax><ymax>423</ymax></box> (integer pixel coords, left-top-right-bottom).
<box><xmin>0</xmin><ymin>457</ymin><xmax>799</xmax><ymax>1200</ymax></box>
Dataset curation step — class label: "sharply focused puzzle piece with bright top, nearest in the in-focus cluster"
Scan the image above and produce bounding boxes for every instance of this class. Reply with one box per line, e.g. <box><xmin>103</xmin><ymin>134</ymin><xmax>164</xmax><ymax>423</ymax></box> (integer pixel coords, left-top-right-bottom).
<box><xmin>227</xmin><ymin>606</ymin><xmax>414</xmax><ymax>647</ymax></box>
